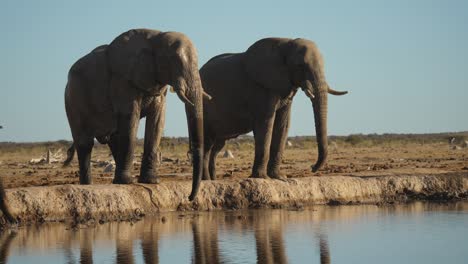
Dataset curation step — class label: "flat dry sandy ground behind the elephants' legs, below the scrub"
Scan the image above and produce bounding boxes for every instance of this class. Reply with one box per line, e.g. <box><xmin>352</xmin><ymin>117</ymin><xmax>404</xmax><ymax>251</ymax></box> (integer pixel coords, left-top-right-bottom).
<box><xmin>0</xmin><ymin>143</ymin><xmax>468</xmax><ymax>188</ymax></box>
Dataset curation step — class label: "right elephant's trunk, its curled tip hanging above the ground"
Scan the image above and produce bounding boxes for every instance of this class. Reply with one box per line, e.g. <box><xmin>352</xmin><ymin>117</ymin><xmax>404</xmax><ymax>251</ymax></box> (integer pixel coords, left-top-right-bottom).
<box><xmin>304</xmin><ymin>80</ymin><xmax>328</xmax><ymax>172</ymax></box>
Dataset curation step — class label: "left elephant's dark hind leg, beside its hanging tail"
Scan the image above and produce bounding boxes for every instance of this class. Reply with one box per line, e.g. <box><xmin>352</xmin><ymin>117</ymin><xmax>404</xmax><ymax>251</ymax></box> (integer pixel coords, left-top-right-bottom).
<box><xmin>75</xmin><ymin>137</ymin><xmax>94</xmax><ymax>184</ymax></box>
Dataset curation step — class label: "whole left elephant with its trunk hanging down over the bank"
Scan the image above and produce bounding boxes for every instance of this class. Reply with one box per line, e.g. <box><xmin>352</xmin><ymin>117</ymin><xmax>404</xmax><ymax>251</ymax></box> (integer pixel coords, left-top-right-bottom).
<box><xmin>65</xmin><ymin>29</ymin><xmax>203</xmax><ymax>200</ymax></box>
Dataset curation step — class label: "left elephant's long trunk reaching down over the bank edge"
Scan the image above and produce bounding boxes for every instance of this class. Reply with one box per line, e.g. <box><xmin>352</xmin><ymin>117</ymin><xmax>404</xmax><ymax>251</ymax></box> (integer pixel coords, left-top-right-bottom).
<box><xmin>174</xmin><ymin>74</ymin><xmax>203</xmax><ymax>201</ymax></box>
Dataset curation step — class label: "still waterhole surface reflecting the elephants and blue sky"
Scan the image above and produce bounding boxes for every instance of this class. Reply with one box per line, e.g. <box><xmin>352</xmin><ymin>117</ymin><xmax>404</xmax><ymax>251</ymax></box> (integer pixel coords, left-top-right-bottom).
<box><xmin>0</xmin><ymin>202</ymin><xmax>468</xmax><ymax>264</ymax></box>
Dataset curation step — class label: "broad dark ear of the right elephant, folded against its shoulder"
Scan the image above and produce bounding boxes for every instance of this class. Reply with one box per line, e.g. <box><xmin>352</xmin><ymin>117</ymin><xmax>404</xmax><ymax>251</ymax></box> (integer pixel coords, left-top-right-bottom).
<box><xmin>244</xmin><ymin>38</ymin><xmax>292</xmax><ymax>96</ymax></box>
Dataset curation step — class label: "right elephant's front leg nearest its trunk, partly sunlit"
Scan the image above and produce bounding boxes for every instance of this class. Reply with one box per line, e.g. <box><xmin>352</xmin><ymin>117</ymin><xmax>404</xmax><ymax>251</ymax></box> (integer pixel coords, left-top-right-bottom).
<box><xmin>268</xmin><ymin>104</ymin><xmax>291</xmax><ymax>180</ymax></box>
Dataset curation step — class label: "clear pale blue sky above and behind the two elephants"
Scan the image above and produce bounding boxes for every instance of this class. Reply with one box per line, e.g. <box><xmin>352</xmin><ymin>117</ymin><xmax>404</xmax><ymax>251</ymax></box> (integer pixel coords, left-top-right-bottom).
<box><xmin>0</xmin><ymin>0</ymin><xmax>468</xmax><ymax>141</ymax></box>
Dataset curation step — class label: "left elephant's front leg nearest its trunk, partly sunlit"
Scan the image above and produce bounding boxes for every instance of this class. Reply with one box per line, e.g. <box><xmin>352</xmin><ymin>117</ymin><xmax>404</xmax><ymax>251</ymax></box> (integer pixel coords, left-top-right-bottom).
<box><xmin>138</xmin><ymin>98</ymin><xmax>166</xmax><ymax>184</ymax></box>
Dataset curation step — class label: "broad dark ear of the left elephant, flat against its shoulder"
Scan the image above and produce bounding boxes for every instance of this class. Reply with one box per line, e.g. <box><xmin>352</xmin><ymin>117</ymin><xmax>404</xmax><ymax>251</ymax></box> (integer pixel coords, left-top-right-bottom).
<box><xmin>108</xmin><ymin>29</ymin><xmax>159</xmax><ymax>90</ymax></box>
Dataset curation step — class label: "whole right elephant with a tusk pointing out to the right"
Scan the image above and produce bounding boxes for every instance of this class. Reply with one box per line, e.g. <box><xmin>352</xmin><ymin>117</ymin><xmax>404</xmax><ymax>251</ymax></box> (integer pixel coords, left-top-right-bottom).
<box><xmin>200</xmin><ymin>38</ymin><xmax>347</xmax><ymax>180</ymax></box>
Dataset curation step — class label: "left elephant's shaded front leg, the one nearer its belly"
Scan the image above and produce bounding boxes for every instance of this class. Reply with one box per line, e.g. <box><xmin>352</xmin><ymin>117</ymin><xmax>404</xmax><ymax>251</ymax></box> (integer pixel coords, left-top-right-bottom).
<box><xmin>112</xmin><ymin>105</ymin><xmax>140</xmax><ymax>184</ymax></box>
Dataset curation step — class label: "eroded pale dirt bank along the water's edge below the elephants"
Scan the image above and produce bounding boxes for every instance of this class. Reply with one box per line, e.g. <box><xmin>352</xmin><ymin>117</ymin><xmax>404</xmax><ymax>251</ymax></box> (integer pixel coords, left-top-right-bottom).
<box><xmin>1</xmin><ymin>173</ymin><xmax>468</xmax><ymax>228</ymax></box>
